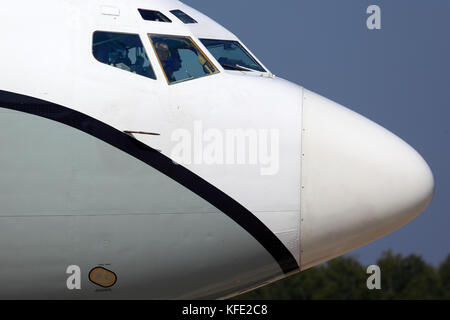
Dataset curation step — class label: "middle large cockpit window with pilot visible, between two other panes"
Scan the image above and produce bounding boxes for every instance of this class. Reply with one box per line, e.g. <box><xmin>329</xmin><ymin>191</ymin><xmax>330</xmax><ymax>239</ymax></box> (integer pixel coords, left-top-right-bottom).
<box><xmin>149</xmin><ymin>34</ymin><xmax>218</xmax><ymax>84</ymax></box>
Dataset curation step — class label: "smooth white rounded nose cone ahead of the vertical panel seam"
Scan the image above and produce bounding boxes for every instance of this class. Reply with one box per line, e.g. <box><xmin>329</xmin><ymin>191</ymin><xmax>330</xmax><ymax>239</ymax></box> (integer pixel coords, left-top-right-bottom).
<box><xmin>300</xmin><ymin>90</ymin><xmax>434</xmax><ymax>270</ymax></box>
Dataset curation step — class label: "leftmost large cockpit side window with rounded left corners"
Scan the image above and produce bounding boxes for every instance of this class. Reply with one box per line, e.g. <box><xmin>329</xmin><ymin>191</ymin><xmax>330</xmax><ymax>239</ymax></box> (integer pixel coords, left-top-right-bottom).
<box><xmin>93</xmin><ymin>31</ymin><xmax>156</xmax><ymax>79</ymax></box>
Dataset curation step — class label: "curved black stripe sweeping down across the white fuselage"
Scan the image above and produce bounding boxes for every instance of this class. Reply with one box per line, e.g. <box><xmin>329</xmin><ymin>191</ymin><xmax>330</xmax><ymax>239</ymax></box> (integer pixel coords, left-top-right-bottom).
<box><xmin>0</xmin><ymin>90</ymin><xmax>299</xmax><ymax>273</ymax></box>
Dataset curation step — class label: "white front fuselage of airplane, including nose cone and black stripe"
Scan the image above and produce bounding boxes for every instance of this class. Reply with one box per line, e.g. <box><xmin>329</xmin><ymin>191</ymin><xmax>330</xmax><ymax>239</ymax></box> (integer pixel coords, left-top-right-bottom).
<box><xmin>0</xmin><ymin>0</ymin><xmax>434</xmax><ymax>299</ymax></box>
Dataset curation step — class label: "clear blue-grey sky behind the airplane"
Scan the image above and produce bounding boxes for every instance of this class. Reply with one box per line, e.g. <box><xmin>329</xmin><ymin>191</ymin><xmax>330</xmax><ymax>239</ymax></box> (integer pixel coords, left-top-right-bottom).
<box><xmin>183</xmin><ymin>0</ymin><xmax>450</xmax><ymax>265</ymax></box>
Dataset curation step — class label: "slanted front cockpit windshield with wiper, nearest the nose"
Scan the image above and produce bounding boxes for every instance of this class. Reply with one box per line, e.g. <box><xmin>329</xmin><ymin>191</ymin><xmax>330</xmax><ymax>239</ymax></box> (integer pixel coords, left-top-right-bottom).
<box><xmin>200</xmin><ymin>39</ymin><xmax>266</xmax><ymax>72</ymax></box>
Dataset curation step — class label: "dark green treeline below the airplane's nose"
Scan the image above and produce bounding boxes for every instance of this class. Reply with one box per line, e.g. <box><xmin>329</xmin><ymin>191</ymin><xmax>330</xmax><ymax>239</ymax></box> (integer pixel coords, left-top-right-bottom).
<box><xmin>235</xmin><ymin>251</ymin><xmax>450</xmax><ymax>300</ymax></box>
